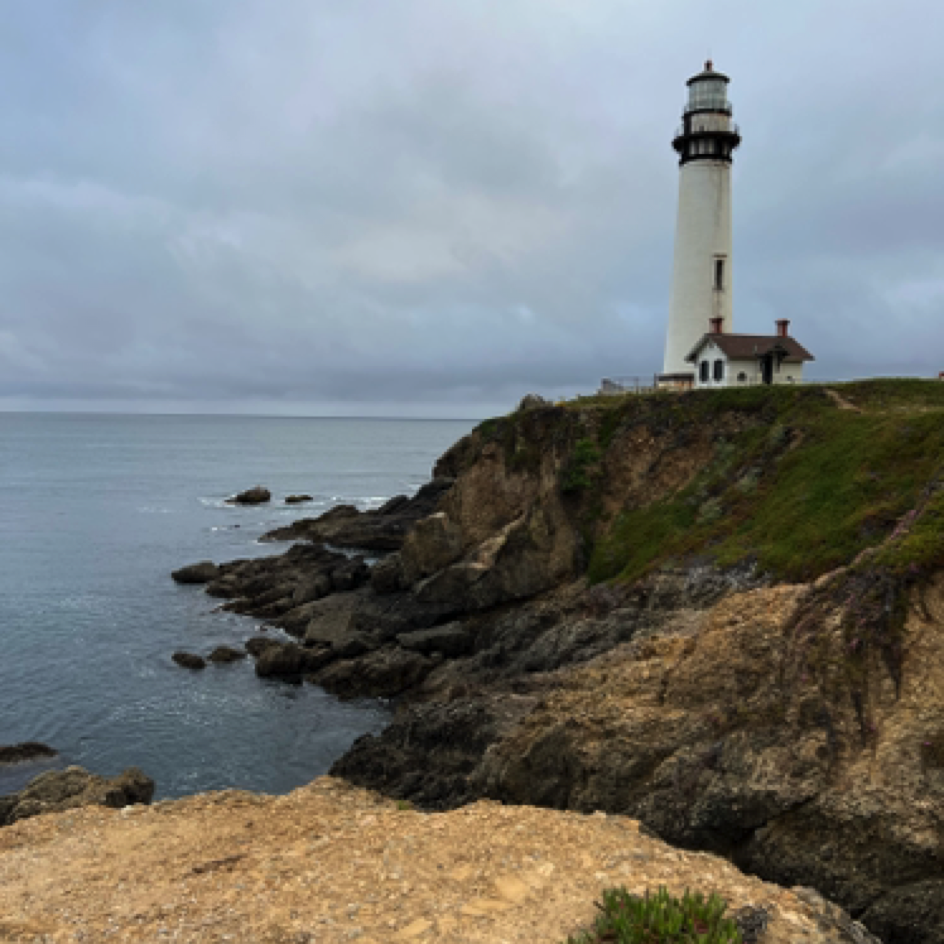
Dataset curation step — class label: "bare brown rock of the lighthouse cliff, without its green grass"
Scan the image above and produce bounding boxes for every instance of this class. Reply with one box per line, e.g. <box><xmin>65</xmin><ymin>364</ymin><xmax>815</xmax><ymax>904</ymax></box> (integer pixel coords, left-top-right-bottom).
<box><xmin>159</xmin><ymin>386</ymin><xmax>944</xmax><ymax>944</ymax></box>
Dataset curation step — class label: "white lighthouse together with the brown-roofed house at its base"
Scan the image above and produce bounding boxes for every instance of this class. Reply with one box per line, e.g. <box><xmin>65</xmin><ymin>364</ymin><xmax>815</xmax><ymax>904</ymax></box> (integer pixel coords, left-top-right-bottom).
<box><xmin>656</xmin><ymin>61</ymin><xmax>813</xmax><ymax>390</ymax></box>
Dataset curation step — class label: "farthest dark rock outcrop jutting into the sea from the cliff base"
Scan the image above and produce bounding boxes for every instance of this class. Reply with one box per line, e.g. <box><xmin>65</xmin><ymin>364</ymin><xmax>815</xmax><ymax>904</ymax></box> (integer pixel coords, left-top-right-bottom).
<box><xmin>262</xmin><ymin>477</ymin><xmax>452</xmax><ymax>551</ymax></box>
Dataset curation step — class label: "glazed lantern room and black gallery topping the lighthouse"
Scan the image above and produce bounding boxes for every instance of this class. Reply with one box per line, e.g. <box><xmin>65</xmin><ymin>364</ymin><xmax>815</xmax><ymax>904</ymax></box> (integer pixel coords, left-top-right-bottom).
<box><xmin>672</xmin><ymin>59</ymin><xmax>741</xmax><ymax>164</ymax></box>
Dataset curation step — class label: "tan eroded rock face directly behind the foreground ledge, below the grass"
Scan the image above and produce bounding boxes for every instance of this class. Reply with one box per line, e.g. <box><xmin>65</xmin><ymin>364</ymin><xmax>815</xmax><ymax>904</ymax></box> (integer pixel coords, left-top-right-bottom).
<box><xmin>473</xmin><ymin>576</ymin><xmax>944</xmax><ymax>942</ymax></box>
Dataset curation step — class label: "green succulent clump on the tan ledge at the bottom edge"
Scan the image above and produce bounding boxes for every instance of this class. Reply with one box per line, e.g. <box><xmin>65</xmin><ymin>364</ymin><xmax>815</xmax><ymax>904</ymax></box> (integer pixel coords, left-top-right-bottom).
<box><xmin>567</xmin><ymin>887</ymin><xmax>742</xmax><ymax>944</ymax></box>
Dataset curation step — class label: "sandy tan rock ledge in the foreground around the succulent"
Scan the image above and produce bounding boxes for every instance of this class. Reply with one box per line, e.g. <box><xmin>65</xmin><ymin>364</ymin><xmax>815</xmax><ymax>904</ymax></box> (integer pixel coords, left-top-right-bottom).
<box><xmin>0</xmin><ymin>777</ymin><xmax>876</xmax><ymax>944</ymax></box>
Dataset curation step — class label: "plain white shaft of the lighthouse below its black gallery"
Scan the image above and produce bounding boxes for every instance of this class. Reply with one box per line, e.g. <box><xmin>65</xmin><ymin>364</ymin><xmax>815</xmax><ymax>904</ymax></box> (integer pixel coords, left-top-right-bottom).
<box><xmin>664</xmin><ymin>160</ymin><xmax>734</xmax><ymax>374</ymax></box>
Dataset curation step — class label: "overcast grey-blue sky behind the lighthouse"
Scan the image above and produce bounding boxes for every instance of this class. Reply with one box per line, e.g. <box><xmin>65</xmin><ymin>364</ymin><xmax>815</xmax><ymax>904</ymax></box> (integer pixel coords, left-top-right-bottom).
<box><xmin>0</xmin><ymin>0</ymin><xmax>944</xmax><ymax>417</ymax></box>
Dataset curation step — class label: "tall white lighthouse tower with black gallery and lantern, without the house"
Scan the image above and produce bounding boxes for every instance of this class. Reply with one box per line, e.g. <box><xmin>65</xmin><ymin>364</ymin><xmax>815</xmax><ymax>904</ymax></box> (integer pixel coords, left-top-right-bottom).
<box><xmin>659</xmin><ymin>60</ymin><xmax>741</xmax><ymax>386</ymax></box>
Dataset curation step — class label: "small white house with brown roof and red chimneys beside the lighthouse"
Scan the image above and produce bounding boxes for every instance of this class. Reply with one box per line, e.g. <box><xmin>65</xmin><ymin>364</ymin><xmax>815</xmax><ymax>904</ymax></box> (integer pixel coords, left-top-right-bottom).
<box><xmin>685</xmin><ymin>318</ymin><xmax>814</xmax><ymax>389</ymax></box>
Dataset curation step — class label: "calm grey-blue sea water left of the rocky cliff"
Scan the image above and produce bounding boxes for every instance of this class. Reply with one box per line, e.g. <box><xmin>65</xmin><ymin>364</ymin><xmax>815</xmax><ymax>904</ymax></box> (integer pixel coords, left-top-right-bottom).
<box><xmin>0</xmin><ymin>414</ymin><xmax>472</xmax><ymax>797</ymax></box>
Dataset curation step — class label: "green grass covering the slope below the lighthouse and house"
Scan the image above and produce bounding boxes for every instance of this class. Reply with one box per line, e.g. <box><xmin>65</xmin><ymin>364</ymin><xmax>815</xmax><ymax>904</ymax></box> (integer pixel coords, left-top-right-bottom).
<box><xmin>589</xmin><ymin>381</ymin><xmax>944</xmax><ymax>582</ymax></box>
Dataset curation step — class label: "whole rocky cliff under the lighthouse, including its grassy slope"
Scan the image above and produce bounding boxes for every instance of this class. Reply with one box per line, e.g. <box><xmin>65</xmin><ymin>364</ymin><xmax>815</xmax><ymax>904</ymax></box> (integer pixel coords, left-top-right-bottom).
<box><xmin>171</xmin><ymin>382</ymin><xmax>944</xmax><ymax>944</ymax></box>
